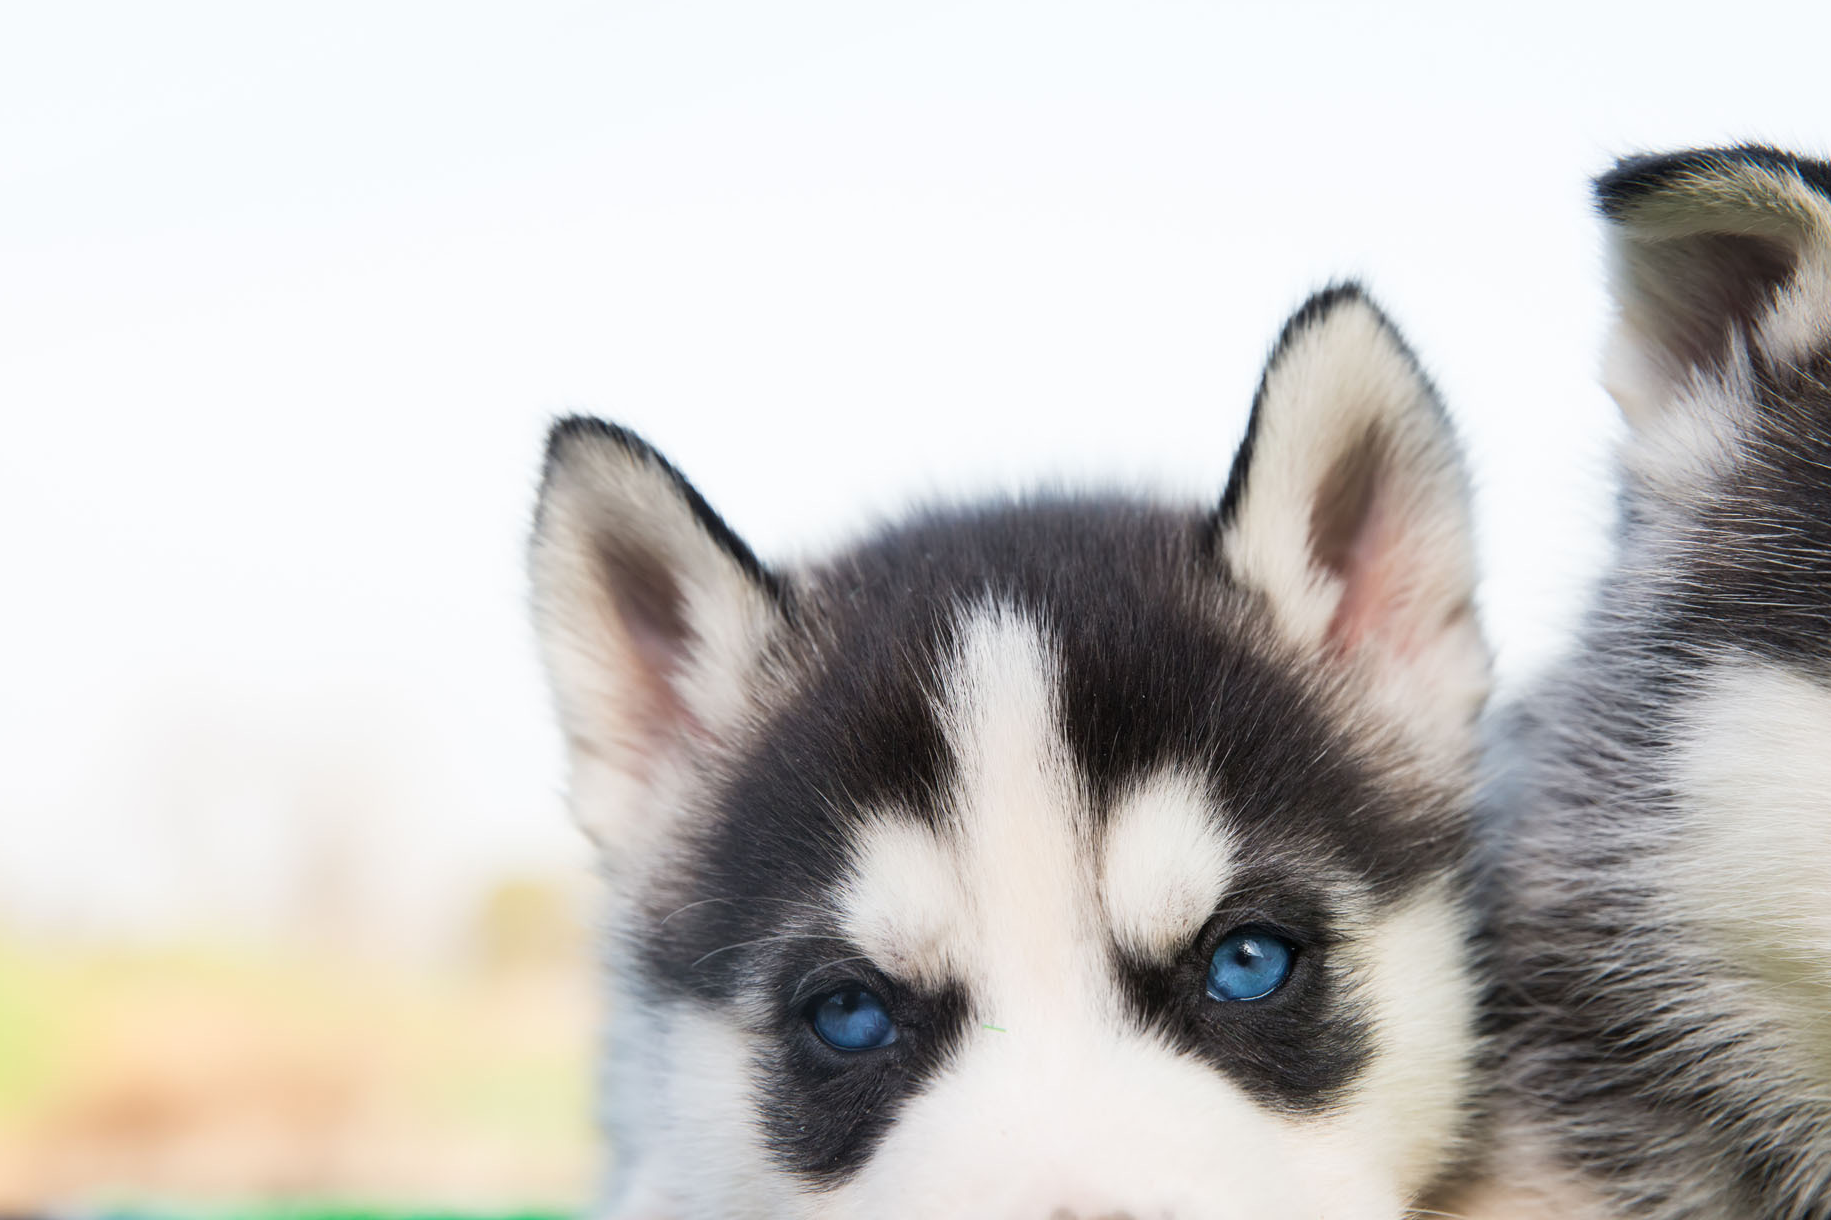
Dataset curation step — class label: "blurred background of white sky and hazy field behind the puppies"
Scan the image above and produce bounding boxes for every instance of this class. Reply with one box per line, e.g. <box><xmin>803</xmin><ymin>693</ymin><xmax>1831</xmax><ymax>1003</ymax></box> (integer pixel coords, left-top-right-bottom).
<box><xmin>0</xmin><ymin>0</ymin><xmax>1831</xmax><ymax>1213</ymax></box>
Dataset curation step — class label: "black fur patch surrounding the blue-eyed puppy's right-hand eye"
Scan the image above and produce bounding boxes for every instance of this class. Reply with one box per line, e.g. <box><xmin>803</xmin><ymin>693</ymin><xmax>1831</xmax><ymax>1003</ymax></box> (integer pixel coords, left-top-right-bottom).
<box><xmin>1111</xmin><ymin>872</ymin><xmax>1371</xmax><ymax>1112</ymax></box>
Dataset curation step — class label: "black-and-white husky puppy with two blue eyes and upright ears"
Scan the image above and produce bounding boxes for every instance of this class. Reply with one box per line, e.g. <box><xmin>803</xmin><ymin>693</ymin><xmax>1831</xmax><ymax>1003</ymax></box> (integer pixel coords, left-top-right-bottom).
<box><xmin>531</xmin><ymin>288</ymin><xmax>1487</xmax><ymax>1220</ymax></box>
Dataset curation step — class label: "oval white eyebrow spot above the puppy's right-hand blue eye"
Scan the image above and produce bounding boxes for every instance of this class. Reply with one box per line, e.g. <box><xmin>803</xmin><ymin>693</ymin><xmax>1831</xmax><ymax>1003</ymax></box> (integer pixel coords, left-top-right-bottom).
<box><xmin>1100</xmin><ymin>775</ymin><xmax>1232</xmax><ymax>958</ymax></box>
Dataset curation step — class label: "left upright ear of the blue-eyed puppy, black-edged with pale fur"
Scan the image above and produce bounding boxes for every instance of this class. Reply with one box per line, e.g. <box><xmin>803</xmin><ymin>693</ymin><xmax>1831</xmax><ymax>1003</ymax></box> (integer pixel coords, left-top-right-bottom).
<box><xmin>529</xmin><ymin>418</ymin><xmax>787</xmax><ymax>861</ymax></box>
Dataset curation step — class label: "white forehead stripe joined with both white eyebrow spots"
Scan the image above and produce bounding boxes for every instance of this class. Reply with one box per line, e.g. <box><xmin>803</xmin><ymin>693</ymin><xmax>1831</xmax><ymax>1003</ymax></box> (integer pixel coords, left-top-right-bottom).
<box><xmin>839</xmin><ymin>608</ymin><xmax>1230</xmax><ymax>984</ymax></box>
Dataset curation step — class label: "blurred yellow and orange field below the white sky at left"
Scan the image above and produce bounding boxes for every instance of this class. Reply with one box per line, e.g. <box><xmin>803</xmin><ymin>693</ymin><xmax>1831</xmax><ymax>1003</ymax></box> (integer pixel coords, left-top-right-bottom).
<box><xmin>0</xmin><ymin>883</ymin><xmax>595</xmax><ymax>1213</ymax></box>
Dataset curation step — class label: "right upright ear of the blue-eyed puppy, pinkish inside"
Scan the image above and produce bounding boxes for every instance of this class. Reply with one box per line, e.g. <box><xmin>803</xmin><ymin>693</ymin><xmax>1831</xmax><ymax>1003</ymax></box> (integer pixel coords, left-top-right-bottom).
<box><xmin>1219</xmin><ymin>284</ymin><xmax>1489</xmax><ymax>753</ymax></box>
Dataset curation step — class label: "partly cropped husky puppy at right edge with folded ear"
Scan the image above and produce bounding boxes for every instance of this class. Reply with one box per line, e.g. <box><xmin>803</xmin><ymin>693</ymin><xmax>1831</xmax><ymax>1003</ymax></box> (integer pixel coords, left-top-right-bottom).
<box><xmin>1452</xmin><ymin>147</ymin><xmax>1831</xmax><ymax>1220</ymax></box>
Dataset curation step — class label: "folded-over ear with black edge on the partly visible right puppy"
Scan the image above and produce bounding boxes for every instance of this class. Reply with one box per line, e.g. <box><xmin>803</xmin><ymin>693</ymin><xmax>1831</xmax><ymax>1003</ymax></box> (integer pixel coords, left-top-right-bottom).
<box><xmin>1597</xmin><ymin>145</ymin><xmax>1831</xmax><ymax>429</ymax></box>
